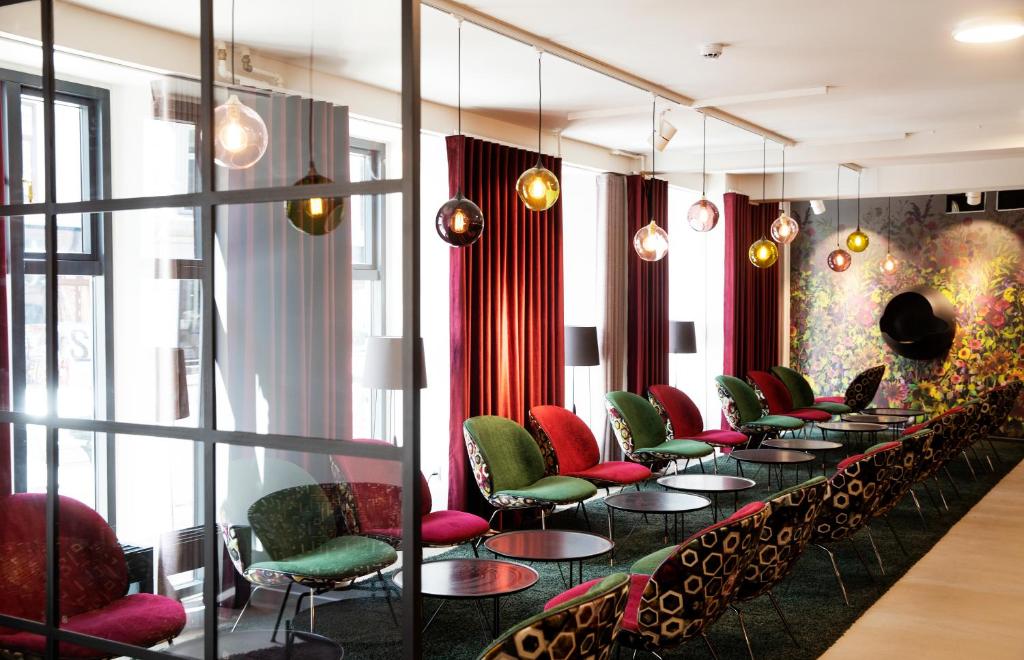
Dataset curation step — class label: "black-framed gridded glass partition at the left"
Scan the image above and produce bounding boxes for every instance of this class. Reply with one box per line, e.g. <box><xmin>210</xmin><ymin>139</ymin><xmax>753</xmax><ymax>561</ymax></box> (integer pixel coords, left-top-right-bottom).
<box><xmin>0</xmin><ymin>0</ymin><xmax>421</xmax><ymax>658</ymax></box>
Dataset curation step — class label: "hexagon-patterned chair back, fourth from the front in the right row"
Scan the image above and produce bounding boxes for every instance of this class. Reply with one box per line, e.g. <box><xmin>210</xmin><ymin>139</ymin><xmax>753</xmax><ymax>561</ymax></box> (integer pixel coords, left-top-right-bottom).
<box><xmin>811</xmin><ymin>442</ymin><xmax>899</xmax><ymax>543</ymax></box>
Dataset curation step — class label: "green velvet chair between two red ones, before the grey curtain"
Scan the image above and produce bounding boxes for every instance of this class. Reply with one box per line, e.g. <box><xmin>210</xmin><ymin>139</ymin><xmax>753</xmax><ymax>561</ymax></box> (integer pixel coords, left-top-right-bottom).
<box><xmin>604</xmin><ymin>392</ymin><xmax>715</xmax><ymax>471</ymax></box>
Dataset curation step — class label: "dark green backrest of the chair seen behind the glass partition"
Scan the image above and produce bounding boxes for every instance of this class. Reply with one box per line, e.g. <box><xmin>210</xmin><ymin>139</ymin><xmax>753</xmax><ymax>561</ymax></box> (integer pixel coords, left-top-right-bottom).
<box><xmin>249</xmin><ymin>484</ymin><xmax>338</xmax><ymax>561</ymax></box>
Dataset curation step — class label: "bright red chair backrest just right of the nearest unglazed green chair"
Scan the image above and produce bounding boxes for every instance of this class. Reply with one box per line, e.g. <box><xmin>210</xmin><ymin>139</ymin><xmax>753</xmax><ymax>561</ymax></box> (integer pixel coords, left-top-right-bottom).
<box><xmin>528</xmin><ymin>405</ymin><xmax>601</xmax><ymax>475</ymax></box>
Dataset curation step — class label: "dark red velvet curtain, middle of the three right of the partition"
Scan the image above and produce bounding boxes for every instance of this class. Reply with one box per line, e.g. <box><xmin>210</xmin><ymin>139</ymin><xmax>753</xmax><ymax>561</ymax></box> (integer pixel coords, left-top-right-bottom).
<box><xmin>623</xmin><ymin>174</ymin><xmax>671</xmax><ymax>396</ymax></box>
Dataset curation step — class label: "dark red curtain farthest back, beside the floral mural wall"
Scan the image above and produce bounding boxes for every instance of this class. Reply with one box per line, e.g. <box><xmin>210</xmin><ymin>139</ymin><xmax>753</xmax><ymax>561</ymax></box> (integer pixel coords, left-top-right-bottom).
<box><xmin>722</xmin><ymin>192</ymin><xmax>782</xmax><ymax>379</ymax></box>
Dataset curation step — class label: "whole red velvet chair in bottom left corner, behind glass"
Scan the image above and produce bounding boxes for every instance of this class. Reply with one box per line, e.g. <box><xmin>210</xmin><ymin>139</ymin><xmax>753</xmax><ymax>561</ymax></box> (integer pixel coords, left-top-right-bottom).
<box><xmin>0</xmin><ymin>493</ymin><xmax>185</xmax><ymax>658</ymax></box>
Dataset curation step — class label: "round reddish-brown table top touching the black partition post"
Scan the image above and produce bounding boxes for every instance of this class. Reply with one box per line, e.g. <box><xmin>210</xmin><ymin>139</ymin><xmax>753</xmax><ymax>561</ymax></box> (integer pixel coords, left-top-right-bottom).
<box><xmin>394</xmin><ymin>559</ymin><xmax>539</xmax><ymax>599</ymax></box>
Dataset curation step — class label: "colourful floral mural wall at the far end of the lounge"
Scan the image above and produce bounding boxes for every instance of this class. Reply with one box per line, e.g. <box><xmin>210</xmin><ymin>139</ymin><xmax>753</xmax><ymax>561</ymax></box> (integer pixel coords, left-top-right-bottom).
<box><xmin>790</xmin><ymin>193</ymin><xmax>1024</xmax><ymax>437</ymax></box>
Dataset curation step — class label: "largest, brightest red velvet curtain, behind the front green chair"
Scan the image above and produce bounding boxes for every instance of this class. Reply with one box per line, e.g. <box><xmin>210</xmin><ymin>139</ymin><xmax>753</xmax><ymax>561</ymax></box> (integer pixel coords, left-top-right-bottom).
<box><xmin>447</xmin><ymin>136</ymin><xmax>565</xmax><ymax>512</ymax></box>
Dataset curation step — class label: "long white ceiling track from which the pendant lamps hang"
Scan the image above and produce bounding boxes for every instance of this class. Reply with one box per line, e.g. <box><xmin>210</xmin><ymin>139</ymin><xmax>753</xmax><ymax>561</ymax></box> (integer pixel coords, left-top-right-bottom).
<box><xmin>421</xmin><ymin>0</ymin><xmax>797</xmax><ymax>146</ymax></box>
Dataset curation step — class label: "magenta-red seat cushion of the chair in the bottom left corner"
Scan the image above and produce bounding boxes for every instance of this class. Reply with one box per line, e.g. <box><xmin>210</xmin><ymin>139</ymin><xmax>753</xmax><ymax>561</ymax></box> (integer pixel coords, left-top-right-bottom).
<box><xmin>0</xmin><ymin>593</ymin><xmax>185</xmax><ymax>658</ymax></box>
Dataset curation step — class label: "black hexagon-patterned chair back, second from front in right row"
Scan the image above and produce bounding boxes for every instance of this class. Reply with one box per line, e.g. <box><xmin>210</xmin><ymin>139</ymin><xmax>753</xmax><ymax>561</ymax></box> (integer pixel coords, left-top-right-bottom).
<box><xmin>637</xmin><ymin>502</ymin><xmax>769</xmax><ymax>650</ymax></box>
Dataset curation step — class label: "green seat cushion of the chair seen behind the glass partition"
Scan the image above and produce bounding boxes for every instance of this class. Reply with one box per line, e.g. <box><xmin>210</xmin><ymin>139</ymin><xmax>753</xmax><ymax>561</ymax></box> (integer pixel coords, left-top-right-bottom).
<box><xmin>246</xmin><ymin>535</ymin><xmax>398</xmax><ymax>583</ymax></box>
